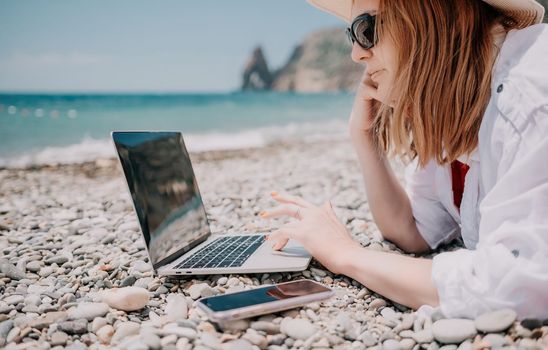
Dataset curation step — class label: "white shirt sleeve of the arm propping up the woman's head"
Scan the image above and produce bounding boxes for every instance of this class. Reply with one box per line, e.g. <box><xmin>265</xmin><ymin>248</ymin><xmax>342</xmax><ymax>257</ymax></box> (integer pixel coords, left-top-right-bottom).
<box><xmin>405</xmin><ymin>160</ymin><xmax>460</xmax><ymax>249</ymax></box>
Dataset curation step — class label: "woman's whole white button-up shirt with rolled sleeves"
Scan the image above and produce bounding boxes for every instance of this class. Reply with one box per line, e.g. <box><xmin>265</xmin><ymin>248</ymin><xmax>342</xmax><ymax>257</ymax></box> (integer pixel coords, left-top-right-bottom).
<box><xmin>406</xmin><ymin>24</ymin><xmax>548</xmax><ymax>319</ymax></box>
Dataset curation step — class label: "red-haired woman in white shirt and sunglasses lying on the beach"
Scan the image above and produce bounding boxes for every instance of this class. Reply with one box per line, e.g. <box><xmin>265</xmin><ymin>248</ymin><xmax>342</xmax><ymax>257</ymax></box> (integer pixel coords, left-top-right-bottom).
<box><xmin>261</xmin><ymin>0</ymin><xmax>548</xmax><ymax>319</ymax></box>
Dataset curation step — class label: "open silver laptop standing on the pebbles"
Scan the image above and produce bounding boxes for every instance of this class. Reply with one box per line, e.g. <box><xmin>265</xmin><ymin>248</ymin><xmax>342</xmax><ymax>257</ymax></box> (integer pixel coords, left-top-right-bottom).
<box><xmin>112</xmin><ymin>131</ymin><xmax>312</xmax><ymax>275</ymax></box>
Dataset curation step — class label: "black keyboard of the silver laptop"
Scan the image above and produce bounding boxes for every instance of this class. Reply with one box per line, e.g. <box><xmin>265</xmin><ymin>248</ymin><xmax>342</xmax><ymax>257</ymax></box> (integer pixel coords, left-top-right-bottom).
<box><xmin>176</xmin><ymin>235</ymin><xmax>265</xmax><ymax>268</ymax></box>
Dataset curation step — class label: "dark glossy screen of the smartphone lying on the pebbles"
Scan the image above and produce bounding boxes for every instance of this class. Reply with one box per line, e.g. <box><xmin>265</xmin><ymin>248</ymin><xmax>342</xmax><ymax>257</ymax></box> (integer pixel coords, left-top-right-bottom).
<box><xmin>200</xmin><ymin>280</ymin><xmax>330</xmax><ymax>312</ymax></box>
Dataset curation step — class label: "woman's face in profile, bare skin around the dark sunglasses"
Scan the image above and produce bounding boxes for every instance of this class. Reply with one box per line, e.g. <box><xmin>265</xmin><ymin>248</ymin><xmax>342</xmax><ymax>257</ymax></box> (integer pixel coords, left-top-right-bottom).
<box><xmin>352</xmin><ymin>0</ymin><xmax>397</xmax><ymax>101</ymax></box>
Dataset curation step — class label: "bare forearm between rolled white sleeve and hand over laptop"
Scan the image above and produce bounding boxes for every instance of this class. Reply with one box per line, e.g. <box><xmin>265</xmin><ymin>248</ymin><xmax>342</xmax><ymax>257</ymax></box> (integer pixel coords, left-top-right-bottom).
<box><xmin>339</xmin><ymin>244</ymin><xmax>439</xmax><ymax>309</ymax></box>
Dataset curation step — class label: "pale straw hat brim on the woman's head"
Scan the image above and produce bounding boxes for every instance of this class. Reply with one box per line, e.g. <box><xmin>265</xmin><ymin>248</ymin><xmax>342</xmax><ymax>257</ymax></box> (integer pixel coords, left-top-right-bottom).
<box><xmin>307</xmin><ymin>0</ymin><xmax>544</xmax><ymax>28</ymax></box>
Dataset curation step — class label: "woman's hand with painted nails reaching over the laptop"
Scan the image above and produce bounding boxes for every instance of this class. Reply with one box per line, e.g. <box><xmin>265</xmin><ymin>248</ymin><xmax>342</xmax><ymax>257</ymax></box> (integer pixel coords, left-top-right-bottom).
<box><xmin>260</xmin><ymin>192</ymin><xmax>359</xmax><ymax>274</ymax></box>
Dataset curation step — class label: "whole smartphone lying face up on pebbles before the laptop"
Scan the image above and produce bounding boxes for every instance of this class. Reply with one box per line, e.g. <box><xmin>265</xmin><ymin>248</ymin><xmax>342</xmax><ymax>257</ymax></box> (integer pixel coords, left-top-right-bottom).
<box><xmin>197</xmin><ymin>279</ymin><xmax>335</xmax><ymax>323</ymax></box>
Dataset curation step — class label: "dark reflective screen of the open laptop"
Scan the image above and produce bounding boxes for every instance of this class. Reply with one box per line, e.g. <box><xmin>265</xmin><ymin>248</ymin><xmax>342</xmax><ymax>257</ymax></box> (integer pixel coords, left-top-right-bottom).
<box><xmin>112</xmin><ymin>132</ymin><xmax>210</xmax><ymax>268</ymax></box>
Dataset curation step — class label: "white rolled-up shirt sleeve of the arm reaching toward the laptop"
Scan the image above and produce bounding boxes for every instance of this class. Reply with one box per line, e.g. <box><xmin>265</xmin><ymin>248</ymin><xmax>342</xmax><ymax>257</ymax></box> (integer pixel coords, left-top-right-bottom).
<box><xmin>432</xmin><ymin>105</ymin><xmax>548</xmax><ymax>319</ymax></box>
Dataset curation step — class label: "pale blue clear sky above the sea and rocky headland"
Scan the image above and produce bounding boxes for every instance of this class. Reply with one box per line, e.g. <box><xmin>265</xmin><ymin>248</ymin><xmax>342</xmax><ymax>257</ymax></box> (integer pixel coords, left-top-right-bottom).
<box><xmin>0</xmin><ymin>0</ymin><xmax>344</xmax><ymax>93</ymax></box>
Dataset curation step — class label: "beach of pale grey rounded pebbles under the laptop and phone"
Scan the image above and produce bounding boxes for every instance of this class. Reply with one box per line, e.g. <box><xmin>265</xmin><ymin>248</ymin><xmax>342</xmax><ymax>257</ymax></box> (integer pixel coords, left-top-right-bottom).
<box><xmin>0</xmin><ymin>140</ymin><xmax>548</xmax><ymax>350</ymax></box>
